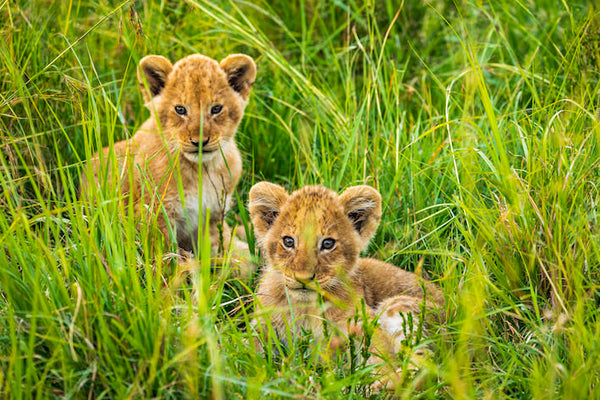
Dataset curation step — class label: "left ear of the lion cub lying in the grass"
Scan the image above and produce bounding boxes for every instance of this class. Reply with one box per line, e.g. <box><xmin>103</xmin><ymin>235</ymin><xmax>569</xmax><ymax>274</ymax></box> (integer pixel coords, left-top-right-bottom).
<box><xmin>248</xmin><ymin>182</ymin><xmax>288</xmax><ymax>242</ymax></box>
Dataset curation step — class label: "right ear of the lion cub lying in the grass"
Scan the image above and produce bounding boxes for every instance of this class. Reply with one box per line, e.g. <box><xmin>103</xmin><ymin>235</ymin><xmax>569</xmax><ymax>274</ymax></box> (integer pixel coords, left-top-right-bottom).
<box><xmin>340</xmin><ymin>185</ymin><xmax>381</xmax><ymax>251</ymax></box>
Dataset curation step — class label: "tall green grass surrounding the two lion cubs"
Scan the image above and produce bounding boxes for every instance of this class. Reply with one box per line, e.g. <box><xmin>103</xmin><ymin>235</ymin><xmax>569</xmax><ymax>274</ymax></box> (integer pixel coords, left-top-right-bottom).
<box><xmin>0</xmin><ymin>0</ymin><xmax>600</xmax><ymax>399</ymax></box>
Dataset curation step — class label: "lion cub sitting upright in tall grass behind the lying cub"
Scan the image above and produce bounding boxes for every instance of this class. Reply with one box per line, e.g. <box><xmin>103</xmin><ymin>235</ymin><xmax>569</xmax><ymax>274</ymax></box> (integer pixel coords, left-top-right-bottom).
<box><xmin>82</xmin><ymin>54</ymin><xmax>256</xmax><ymax>266</ymax></box>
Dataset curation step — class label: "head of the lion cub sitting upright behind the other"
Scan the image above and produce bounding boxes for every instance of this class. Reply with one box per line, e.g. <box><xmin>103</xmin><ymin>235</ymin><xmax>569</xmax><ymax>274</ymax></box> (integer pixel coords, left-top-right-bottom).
<box><xmin>138</xmin><ymin>54</ymin><xmax>256</xmax><ymax>161</ymax></box>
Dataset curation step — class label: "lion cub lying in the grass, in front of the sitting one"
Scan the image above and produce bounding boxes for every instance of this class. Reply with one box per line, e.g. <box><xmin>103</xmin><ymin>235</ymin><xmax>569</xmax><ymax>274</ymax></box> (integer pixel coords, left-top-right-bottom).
<box><xmin>249</xmin><ymin>182</ymin><xmax>444</xmax><ymax>380</ymax></box>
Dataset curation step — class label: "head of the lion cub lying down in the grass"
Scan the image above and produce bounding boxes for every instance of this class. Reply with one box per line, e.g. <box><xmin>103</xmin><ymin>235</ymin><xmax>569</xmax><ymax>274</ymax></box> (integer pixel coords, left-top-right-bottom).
<box><xmin>249</xmin><ymin>182</ymin><xmax>381</xmax><ymax>301</ymax></box>
